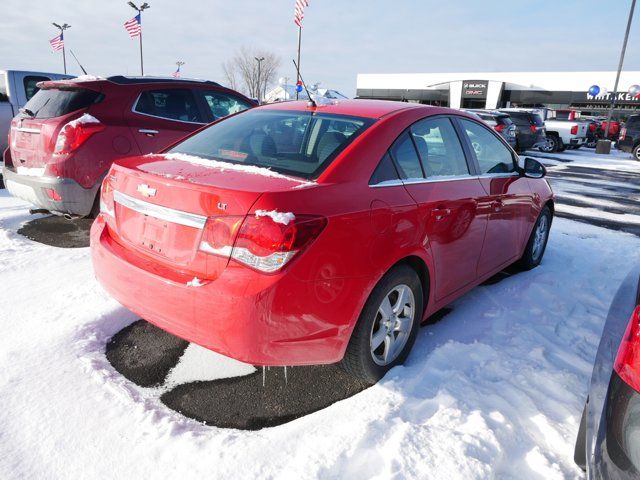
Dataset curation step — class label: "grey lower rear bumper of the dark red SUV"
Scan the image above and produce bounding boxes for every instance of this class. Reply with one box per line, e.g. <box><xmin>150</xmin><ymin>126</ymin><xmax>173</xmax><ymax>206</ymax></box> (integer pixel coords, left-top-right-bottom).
<box><xmin>3</xmin><ymin>167</ymin><xmax>100</xmax><ymax>216</ymax></box>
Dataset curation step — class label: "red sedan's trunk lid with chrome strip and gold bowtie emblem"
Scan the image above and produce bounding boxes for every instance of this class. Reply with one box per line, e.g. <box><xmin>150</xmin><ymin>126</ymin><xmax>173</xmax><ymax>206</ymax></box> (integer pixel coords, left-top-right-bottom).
<box><xmin>109</xmin><ymin>155</ymin><xmax>312</xmax><ymax>280</ymax></box>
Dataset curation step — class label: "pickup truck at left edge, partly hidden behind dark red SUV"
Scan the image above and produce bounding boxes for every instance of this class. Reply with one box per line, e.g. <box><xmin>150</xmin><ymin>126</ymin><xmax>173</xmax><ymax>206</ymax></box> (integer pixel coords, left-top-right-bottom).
<box><xmin>0</xmin><ymin>70</ymin><xmax>71</xmax><ymax>178</ymax></box>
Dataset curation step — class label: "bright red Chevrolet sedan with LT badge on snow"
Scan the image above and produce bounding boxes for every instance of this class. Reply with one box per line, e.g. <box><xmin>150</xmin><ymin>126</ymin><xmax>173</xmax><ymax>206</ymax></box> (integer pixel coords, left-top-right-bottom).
<box><xmin>91</xmin><ymin>100</ymin><xmax>553</xmax><ymax>382</ymax></box>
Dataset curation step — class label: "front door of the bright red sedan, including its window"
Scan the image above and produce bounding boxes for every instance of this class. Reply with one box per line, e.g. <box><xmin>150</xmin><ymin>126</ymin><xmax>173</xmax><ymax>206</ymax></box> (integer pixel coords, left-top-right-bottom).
<box><xmin>459</xmin><ymin>118</ymin><xmax>533</xmax><ymax>276</ymax></box>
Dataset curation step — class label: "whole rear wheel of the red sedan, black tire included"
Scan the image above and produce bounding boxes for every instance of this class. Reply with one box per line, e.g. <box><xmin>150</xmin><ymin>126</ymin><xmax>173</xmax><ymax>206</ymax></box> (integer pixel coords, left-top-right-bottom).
<box><xmin>341</xmin><ymin>264</ymin><xmax>424</xmax><ymax>384</ymax></box>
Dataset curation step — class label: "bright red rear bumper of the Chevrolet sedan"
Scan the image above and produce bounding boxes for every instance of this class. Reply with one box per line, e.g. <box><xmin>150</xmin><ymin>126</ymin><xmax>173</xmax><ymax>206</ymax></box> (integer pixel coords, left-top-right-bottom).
<box><xmin>91</xmin><ymin>215</ymin><xmax>365</xmax><ymax>365</ymax></box>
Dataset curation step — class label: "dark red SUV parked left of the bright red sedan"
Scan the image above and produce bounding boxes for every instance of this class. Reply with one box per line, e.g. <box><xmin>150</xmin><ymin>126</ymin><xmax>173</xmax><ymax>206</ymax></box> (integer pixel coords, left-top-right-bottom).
<box><xmin>4</xmin><ymin>76</ymin><xmax>256</xmax><ymax>216</ymax></box>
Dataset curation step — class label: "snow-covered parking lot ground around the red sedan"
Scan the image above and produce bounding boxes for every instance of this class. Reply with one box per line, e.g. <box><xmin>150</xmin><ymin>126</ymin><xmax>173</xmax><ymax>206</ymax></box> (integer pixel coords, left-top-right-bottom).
<box><xmin>0</xmin><ymin>150</ymin><xmax>640</xmax><ymax>479</ymax></box>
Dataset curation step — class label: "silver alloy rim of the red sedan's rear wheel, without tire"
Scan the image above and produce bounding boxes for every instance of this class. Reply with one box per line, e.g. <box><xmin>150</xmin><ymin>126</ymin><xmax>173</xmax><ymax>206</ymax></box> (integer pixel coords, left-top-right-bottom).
<box><xmin>369</xmin><ymin>285</ymin><xmax>416</xmax><ymax>366</ymax></box>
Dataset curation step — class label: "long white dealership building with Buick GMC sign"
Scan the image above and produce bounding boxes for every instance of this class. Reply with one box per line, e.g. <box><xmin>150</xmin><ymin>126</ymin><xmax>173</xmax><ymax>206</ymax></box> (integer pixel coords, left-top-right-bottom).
<box><xmin>356</xmin><ymin>72</ymin><xmax>640</xmax><ymax>116</ymax></box>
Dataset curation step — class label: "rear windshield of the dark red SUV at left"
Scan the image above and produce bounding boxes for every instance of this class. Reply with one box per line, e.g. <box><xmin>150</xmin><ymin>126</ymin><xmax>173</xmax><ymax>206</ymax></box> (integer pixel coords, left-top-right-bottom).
<box><xmin>23</xmin><ymin>88</ymin><xmax>102</xmax><ymax>118</ymax></box>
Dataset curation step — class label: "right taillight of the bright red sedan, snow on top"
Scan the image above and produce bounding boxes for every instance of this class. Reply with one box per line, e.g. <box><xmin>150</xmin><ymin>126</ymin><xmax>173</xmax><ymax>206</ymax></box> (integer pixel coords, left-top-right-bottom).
<box><xmin>199</xmin><ymin>215</ymin><xmax>327</xmax><ymax>273</ymax></box>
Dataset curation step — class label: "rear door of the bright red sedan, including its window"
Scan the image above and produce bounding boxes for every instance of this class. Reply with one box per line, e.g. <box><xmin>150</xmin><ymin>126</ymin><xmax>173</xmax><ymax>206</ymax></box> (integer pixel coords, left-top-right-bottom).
<box><xmin>390</xmin><ymin>116</ymin><xmax>487</xmax><ymax>300</ymax></box>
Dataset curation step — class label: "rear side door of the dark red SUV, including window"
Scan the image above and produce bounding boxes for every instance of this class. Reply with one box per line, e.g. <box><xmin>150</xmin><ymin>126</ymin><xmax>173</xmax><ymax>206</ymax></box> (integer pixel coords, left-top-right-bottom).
<box><xmin>126</xmin><ymin>87</ymin><xmax>207</xmax><ymax>154</ymax></box>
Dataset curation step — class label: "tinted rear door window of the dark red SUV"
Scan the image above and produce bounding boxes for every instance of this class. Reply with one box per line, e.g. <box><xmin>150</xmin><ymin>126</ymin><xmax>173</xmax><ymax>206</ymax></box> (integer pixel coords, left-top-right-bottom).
<box><xmin>134</xmin><ymin>88</ymin><xmax>204</xmax><ymax>123</ymax></box>
